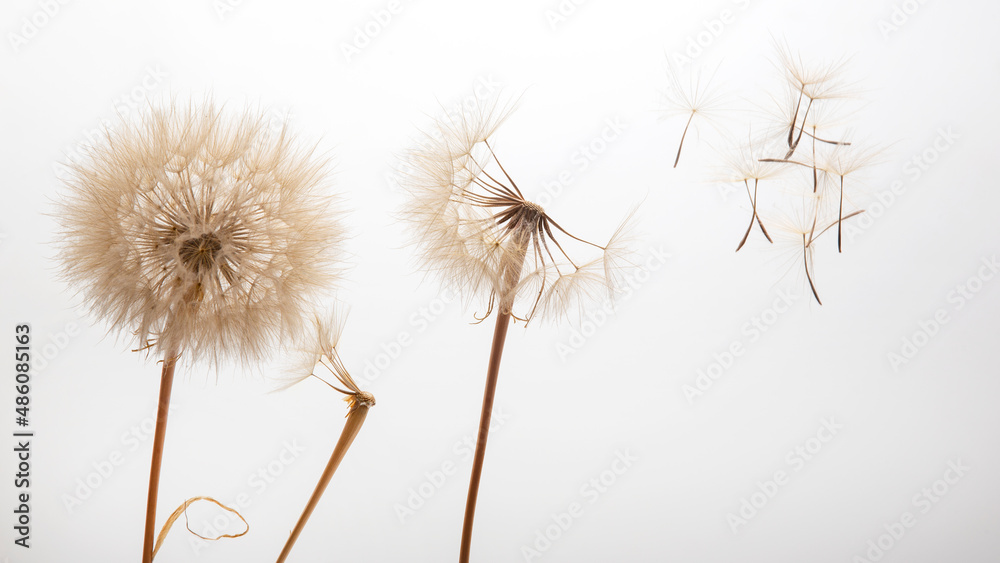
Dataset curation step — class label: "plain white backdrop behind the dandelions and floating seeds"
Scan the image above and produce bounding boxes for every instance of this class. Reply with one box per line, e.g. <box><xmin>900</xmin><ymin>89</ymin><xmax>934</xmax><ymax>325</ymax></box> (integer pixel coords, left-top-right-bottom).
<box><xmin>0</xmin><ymin>0</ymin><xmax>1000</xmax><ymax>563</ymax></box>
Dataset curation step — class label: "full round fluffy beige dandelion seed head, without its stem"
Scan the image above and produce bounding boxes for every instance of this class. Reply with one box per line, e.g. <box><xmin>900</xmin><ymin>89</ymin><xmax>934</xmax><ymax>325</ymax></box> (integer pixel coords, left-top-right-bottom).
<box><xmin>58</xmin><ymin>99</ymin><xmax>345</xmax><ymax>363</ymax></box>
